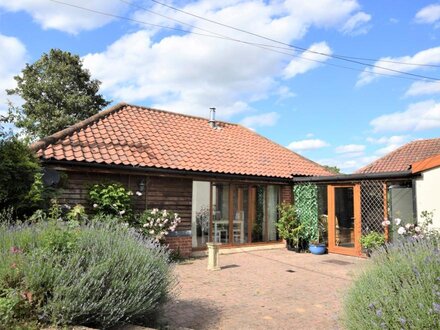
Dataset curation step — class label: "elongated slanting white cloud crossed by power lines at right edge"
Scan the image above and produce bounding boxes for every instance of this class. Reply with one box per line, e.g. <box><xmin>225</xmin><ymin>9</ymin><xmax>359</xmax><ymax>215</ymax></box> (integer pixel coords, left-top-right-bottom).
<box><xmin>356</xmin><ymin>47</ymin><xmax>440</xmax><ymax>86</ymax></box>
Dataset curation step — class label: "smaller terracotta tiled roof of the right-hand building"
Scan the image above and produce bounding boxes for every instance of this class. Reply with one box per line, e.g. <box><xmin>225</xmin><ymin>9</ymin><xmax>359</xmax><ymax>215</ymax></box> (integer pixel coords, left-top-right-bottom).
<box><xmin>356</xmin><ymin>138</ymin><xmax>440</xmax><ymax>173</ymax></box>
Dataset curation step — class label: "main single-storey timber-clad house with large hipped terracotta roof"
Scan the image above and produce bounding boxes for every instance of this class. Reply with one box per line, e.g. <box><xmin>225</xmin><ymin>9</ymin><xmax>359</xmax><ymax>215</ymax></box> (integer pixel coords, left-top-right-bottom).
<box><xmin>32</xmin><ymin>103</ymin><xmax>330</xmax><ymax>255</ymax></box>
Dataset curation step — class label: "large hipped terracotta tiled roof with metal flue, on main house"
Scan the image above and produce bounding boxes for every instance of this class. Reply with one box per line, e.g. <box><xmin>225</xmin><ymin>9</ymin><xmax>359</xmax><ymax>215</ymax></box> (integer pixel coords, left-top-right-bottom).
<box><xmin>32</xmin><ymin>104</ymin><xmax>331</xmax><ymax>178</ymax></box>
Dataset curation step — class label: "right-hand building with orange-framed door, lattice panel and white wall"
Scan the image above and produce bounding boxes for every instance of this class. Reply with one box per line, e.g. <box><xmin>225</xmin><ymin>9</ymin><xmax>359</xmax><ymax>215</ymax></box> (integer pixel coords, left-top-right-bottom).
<box><xmin>292</xmin><ymin>138</ymin><xmax>440</xmax><ymax>255</ymax></box>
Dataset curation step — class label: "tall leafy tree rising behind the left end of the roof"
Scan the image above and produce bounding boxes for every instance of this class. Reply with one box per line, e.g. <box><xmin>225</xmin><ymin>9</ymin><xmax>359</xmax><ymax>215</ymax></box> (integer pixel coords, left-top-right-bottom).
<box><xmin>6</xmin><ymin>49</ymin><xmax>110</xmax><ymax>138</ymax></box>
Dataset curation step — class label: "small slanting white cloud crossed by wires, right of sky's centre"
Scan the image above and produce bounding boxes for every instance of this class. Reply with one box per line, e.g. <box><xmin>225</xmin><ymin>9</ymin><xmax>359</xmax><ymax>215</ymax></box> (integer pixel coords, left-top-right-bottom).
<box><xmin>283</xmin><ymin>42</ymin><xmax>332</xmax><ymax>79</ymax></box>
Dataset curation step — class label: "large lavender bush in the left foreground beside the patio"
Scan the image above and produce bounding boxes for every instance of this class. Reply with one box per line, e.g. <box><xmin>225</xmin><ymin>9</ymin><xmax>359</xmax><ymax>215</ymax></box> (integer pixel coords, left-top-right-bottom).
<box><xmin>0</xmin><ymin>221</ymin><xmax>176</xmax><ymax>328</ymax></box>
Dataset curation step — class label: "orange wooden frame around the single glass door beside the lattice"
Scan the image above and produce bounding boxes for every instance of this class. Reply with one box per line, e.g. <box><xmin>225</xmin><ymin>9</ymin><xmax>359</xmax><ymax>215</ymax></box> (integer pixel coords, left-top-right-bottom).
<box><xmin>327</xmin><ymin>183</ymin><xmax>362</xmax><ymax>256</ymax></box>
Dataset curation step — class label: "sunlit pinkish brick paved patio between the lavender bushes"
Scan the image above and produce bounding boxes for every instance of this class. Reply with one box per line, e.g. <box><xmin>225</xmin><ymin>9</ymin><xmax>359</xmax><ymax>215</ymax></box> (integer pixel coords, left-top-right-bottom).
<box><xmin>164</xmin><ymin>249</ymin><xmax>366</xmax><ymax>329</ymax></box>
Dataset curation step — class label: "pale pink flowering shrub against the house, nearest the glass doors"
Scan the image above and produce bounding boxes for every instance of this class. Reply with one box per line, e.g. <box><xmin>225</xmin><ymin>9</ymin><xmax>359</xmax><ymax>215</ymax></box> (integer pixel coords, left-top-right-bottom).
<box><xmin>138</xmin><ymin>209</ymin><xmax>181</xmax><ymax>242</ymax></box>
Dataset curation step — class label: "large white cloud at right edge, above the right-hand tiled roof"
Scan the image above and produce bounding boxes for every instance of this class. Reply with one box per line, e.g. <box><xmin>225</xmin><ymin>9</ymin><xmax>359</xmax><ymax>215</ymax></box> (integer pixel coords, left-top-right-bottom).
<box><xmin>370</xmin><ymin>100</ymin><xmax>440</xmax><ymax>132</ymax></box>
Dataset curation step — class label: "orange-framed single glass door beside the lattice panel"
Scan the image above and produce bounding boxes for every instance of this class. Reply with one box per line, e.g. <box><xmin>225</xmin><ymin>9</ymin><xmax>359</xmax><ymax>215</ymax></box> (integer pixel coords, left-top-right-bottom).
<box><xmin>328</xmin><ymin>184</ymin><xmax>361</xmax><ymax>255</ymax></box>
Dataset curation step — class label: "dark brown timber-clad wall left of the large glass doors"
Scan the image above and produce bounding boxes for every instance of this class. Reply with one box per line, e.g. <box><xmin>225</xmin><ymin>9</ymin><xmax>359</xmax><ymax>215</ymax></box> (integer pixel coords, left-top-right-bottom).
<box><xmin>54</xmin><ymin>171</ymin><xmax>192</xmax><ymax>231</ymax></box>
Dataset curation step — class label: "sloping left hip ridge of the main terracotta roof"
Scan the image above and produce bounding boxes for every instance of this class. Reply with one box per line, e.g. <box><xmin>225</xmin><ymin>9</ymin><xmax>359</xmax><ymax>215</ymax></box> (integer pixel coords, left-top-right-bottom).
<box><xmin>30</xmin><ymin>102</ymin><xmax>128</xmax><ymax>152</ymax></box>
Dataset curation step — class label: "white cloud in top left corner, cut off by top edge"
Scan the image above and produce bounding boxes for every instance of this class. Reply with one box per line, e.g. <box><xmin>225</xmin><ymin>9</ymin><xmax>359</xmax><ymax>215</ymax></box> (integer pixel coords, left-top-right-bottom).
<box><xmin>0</xmin><ymin>0</ymin><xmax>125</xmax><ymax>34</ymax></box>
